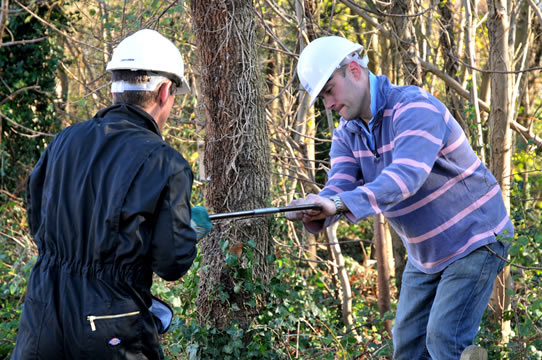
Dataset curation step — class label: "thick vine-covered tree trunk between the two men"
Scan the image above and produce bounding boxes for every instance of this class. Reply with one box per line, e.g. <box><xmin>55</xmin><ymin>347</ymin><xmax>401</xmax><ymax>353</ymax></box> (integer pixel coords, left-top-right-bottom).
<box><xmin>190</xmin><ymin>0</ymin><xmax>273</xmax><ymax>329</ymax></box>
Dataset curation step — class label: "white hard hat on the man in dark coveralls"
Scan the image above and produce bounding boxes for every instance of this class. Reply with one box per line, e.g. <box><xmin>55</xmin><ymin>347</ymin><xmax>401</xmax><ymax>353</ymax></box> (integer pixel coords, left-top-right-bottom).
<box><xmin>106</xmin><ymin>29</ymin><xmax>190</xmax><ymax>94</ymax></box>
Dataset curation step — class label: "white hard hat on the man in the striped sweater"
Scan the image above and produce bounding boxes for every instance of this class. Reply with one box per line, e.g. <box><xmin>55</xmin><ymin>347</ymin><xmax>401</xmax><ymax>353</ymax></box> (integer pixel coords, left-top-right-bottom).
<box><xmin>297</xmin><ymin>36</ymin><xmax>368</xmax><ymax>106</ymax></box>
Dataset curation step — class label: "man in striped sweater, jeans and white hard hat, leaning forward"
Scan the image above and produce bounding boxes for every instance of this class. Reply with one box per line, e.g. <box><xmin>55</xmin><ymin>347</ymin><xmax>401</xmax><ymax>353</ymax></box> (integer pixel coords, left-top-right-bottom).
<box><xmin>287</xmin><ymin>36</ymin><xmax>513</xmax><ymax>360</ymax></box>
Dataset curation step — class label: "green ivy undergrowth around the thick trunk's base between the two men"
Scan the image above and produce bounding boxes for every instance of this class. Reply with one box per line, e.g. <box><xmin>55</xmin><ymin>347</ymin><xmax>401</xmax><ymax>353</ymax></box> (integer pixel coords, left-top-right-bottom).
<box><xmin>154</xmin><ymin>217</ymin><xmax>391</xmax><ymax>359</ymax></box>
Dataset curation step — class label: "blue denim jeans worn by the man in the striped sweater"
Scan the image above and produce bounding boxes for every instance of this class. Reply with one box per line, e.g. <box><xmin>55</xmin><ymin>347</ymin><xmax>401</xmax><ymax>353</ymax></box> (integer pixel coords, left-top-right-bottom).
<box><xmin>393</xmin><ymin>241</ymin><xmax>508</xmax><ymax>360</ymax></box>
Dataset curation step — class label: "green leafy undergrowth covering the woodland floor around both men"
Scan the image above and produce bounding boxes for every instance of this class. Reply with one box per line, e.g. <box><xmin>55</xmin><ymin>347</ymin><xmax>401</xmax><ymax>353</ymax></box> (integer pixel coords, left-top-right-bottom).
<box><xmin>0</xmin><ymin>198</ymin><xmax>542</xmax><ymax>360</ymax></box>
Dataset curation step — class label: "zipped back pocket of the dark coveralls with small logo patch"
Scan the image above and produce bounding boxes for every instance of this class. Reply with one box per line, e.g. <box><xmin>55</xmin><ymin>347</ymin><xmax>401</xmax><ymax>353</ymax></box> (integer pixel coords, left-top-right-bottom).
<box><xmin>85</xmin><ymin>306</ymin><xmax>146</xmax><ymax>359</ymax></box>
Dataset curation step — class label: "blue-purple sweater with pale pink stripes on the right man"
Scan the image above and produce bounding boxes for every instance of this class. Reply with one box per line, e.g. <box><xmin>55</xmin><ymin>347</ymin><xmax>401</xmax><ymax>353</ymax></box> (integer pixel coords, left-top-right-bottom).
<box><xmin>306</xmin><ymin>74</ymin><xmax>513</xmax><ymax>273</ymax></box>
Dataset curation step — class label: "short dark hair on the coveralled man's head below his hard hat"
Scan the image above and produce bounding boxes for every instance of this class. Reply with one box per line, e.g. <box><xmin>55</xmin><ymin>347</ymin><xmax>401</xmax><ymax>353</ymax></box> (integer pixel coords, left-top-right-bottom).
<box><xmin>111</xmin><ymin>70</ymin><xmax>176</xmax><ymax>107</ymax></box>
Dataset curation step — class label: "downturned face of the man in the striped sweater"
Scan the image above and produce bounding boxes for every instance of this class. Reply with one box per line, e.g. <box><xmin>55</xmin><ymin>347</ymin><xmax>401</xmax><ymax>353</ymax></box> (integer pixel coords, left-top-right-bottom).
<box><xmin>319</xmin><ymin>64</ymin><xmax>369</xmax><ymax>120</ymax></box>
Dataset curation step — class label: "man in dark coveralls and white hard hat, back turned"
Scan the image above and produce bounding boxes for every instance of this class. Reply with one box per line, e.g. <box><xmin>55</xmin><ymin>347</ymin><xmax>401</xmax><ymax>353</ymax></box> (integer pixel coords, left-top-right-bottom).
<box><xmin>12</xmin><ymin>29</ymin><xmax>210</xmax><ymax>360</ymax></box>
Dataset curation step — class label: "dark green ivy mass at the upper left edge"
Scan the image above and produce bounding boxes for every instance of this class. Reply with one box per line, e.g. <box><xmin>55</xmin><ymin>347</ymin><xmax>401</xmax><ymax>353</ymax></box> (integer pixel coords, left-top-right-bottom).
<box><xmin>0</xmin><ymin>1</ymin><xmax>68</xmax><ymax>193</ymax></box>
